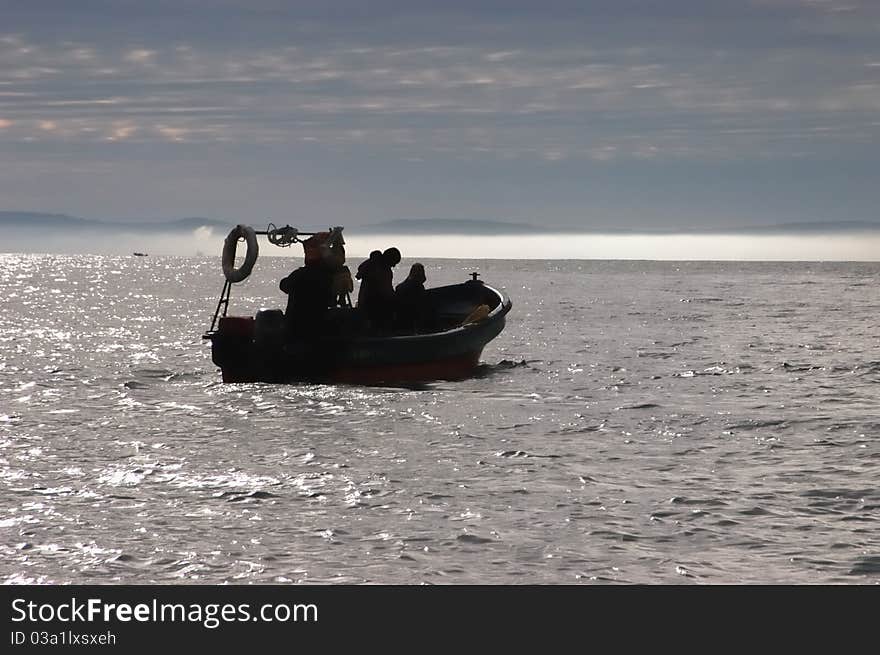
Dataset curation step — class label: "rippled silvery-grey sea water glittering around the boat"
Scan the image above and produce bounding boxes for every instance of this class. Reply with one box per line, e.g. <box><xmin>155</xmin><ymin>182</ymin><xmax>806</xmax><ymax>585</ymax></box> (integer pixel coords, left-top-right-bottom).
<box><xmin>0</xmin><ymin>255</ymin><xmax>880</xmax><ymax>584</ymax></box>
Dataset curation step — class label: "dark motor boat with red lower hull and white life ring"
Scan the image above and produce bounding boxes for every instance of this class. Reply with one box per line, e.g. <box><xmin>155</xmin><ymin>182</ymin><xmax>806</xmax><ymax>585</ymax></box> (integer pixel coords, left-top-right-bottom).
<box><xmin>203</xmin><ymin>224</ymin><xmax>512</xmax><ymax>384</ymax></box>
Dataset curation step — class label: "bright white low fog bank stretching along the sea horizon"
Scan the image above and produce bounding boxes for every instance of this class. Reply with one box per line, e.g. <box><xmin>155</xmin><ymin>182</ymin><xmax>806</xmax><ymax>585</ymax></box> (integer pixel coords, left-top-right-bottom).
<box><xmin>0</xmin><ymin>227</ymin><xmax>880</xmax><ymax>263</ymax></box>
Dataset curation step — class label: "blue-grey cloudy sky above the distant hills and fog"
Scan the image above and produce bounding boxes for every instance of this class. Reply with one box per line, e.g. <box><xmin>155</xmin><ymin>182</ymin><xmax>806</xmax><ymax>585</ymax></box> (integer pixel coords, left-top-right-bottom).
<box><xmin>0</xmin><ymin>0</ymin><xmax>880</xmax><ymax>229</ymax></box>
